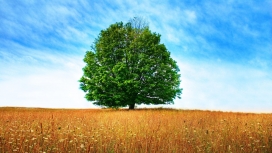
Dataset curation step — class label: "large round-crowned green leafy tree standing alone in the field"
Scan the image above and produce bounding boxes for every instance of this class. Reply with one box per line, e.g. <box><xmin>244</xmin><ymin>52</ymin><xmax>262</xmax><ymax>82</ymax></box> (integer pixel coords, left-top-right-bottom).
<box><xmin>79</xmin><ymin>18</ymin><xmax>182</xmax><ymax>109</ymax></box>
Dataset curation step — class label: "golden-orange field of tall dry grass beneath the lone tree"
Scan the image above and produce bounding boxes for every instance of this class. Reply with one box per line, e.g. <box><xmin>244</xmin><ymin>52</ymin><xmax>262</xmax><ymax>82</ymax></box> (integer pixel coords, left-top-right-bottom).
<box><xmin>0</xmin><ymin>108</ymin><xmax>272</xmax><ymax>153</ymax></box>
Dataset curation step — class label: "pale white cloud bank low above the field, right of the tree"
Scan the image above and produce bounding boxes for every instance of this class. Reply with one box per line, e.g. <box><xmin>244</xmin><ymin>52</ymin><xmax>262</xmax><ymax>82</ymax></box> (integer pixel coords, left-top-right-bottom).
<box><xmin>173</xmin><ymin>56</ymin><xmax>272</xmax><ymax>112</ymax></box>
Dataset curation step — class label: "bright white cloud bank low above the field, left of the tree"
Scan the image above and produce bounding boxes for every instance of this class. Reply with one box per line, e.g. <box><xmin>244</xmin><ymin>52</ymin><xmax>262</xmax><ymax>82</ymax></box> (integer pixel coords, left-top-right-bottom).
<box><xmin>0</xmin><ymin>53</ymin><xmax>98</xmax><ymax>108</ymax></box>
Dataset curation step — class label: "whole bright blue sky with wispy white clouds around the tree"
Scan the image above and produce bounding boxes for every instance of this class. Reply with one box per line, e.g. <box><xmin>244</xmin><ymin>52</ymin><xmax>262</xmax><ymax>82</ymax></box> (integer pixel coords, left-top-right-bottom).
<box><xmin>0</xmin><ymin>0</ymin><xmax>272</xmax><ymax>112</ymax></box>
